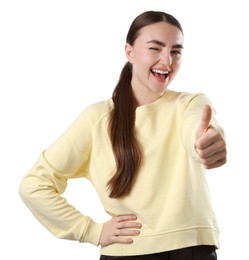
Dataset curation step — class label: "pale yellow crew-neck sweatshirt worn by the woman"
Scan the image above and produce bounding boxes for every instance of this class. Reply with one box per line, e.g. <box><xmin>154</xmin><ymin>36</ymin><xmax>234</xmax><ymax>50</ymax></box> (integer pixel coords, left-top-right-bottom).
<box><xmin>19</xmin><ymin>90</ymin><xmax>222</xmax><ymax>256</ymax></box>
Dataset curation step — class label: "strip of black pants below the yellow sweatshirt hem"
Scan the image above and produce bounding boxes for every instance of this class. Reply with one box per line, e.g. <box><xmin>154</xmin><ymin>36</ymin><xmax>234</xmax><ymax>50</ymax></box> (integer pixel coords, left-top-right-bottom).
<box><xmin>100</xmin><ymin>246</ymin><xmax>217</xmax><ymax>260</ymax></box>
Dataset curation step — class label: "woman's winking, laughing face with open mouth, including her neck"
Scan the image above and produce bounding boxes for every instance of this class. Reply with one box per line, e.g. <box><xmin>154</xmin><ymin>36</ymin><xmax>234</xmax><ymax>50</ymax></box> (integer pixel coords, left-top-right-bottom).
<box><xmin>125</xmin><ymin>22</ymin><xmax>183</xmax><ymax>105</ymax></box>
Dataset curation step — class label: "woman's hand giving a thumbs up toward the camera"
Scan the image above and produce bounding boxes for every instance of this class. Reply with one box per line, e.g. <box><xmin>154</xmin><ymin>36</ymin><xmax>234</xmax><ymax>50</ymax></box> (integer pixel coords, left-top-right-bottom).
<box><xmin>195</xmin><ymin>105</ymin><xmax>227</xmax><ymax>169</ymax></box>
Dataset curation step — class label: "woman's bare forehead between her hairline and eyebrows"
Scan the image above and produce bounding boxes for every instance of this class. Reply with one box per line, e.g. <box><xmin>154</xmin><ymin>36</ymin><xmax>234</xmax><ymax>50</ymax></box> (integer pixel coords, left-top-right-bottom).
<box><xmin>136</xmin><ymin>22</ymin><xmax>183</xmax><ymax>45</ymax></box>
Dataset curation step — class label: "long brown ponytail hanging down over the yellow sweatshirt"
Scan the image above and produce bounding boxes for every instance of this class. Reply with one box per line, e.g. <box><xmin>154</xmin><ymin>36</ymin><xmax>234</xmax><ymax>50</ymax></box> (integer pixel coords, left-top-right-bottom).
<box><xmin>107</xmin><ymin>62</ymin><xmax>142</xmax><ymax>198</ymax></box>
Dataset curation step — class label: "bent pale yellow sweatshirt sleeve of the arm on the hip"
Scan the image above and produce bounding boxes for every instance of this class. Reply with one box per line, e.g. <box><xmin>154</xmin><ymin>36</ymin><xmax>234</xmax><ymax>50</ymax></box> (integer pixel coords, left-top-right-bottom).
<box><xmin>19</xmin><ymin>107</ymin><xmax>102</xmax><ymax>245</ymax></box>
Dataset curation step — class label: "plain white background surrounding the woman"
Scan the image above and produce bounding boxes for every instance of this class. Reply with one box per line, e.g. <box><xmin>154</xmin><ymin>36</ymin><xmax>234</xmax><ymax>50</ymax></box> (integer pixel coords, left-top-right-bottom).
<box><xmin>0</xmin><ymin>0</ymin><xmax>249</xmax><ymax>260</ymax></box>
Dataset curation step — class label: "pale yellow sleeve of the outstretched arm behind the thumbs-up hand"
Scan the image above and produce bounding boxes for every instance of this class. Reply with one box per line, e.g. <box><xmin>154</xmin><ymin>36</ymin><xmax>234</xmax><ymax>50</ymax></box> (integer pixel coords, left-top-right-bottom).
<box><xmin>181</xmin><ymin>93</ymin><xmax>224</xmax><ymax>161</ymax></box>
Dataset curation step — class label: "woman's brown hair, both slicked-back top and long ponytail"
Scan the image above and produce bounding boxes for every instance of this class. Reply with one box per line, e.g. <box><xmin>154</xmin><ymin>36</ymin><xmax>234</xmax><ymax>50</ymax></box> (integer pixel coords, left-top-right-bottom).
<box><xmin>107</xmin><ymin>11</ymin><xmax>182</xmax><ymax>198</ymax></box>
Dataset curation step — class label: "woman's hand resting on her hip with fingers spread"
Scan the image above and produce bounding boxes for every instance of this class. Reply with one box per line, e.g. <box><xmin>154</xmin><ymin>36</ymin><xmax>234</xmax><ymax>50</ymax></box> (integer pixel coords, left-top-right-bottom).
<box><xmin>99</xmin><ymin>215</ymin><xmax>142</xmax><ymax>246</ymax></box>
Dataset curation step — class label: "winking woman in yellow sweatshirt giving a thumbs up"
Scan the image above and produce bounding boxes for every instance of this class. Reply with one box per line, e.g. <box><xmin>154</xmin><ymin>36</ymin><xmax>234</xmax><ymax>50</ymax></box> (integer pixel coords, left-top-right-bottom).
<box><xmin>19</xmin><ymin>11</ymin><xmax>226</xmax><ymax>260</ymax></box>
